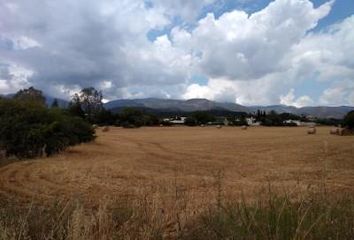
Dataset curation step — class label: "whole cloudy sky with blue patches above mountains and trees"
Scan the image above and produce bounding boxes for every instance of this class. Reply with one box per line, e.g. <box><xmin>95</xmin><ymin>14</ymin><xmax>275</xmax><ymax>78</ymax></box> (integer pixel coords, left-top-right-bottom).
<box><xmin>0</xmin><ymin>0</ymin><xmax>354</xmax><ymax>107</ymax></box>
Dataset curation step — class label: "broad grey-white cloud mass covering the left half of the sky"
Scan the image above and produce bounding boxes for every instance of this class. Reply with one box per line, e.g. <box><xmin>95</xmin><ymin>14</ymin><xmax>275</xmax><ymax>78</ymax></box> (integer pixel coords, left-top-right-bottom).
<box><xmin>0</xmin><ymin>0</ymin><xmax>188</xmax><ymax>97</ymax></box>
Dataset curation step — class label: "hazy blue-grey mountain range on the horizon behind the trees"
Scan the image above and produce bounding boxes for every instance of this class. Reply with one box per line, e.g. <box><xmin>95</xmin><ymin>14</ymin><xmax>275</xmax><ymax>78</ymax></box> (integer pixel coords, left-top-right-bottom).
<box><xmin>1</xmin><ymin>94</ymin><xmax>354</xmax><ymax>119</ymax></box>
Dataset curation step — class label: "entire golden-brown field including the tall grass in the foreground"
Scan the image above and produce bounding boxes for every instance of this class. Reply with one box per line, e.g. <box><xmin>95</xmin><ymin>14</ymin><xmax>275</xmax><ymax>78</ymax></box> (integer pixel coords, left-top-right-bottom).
<box><xmin>0</xmin><ymin>127</ymin><xmax>354</xmax><ymax>240</ymax></box>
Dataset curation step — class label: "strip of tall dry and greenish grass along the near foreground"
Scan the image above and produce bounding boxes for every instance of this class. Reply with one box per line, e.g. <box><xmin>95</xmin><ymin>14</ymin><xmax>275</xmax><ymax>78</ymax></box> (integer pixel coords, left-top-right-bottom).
<box><xmin>0</xmin><ymin>181</ymin><xmax>354</xmax><ymax>240</ymax></box>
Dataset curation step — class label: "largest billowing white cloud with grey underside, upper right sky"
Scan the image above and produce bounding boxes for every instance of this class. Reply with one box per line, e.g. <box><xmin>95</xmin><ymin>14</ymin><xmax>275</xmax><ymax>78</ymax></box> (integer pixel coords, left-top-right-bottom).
<box><xmin>185</xmin><ymin>0</ymin><xmax>332</xmax><ymax>80</ymax></box>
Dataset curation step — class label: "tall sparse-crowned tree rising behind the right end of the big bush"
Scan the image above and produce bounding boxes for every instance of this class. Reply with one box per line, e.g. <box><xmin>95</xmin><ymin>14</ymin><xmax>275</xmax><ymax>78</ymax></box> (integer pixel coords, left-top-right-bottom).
<box><xmin>71</xmin><ymin>87</ymin><xmax>103</xmax><ymax>123</ymax></box>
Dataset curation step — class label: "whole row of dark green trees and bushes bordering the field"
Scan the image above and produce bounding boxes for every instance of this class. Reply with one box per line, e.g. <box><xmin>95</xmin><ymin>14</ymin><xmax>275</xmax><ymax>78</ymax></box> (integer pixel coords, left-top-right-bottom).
<box><xmin>0</xmin><ymin>87</ymin><xmax>354</xmax><ymax>158</ymax></box>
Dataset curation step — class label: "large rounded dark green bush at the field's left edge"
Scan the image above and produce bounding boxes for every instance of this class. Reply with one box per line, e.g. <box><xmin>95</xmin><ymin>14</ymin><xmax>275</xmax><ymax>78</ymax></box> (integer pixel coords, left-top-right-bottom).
<box><xmin>0</xmin><ymin>99</ymin><xmax>94</xmax><ymax>158</ymax></box>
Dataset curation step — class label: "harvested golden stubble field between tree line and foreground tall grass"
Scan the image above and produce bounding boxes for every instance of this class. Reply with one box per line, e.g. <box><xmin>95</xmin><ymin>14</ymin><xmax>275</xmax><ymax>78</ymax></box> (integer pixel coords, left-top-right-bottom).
<box><xmin>0</xmin><ymin>127</ymin><xmax>354</xmax><ymax>204</ymax></box>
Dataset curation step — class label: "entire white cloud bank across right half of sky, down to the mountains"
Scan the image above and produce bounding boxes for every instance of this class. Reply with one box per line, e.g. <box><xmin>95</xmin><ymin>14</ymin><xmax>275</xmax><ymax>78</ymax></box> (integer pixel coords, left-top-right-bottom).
<box><xmin>181</xmin><ymin>0</ymin><xmax>354</xmax><ymax>107</ymax></box>
